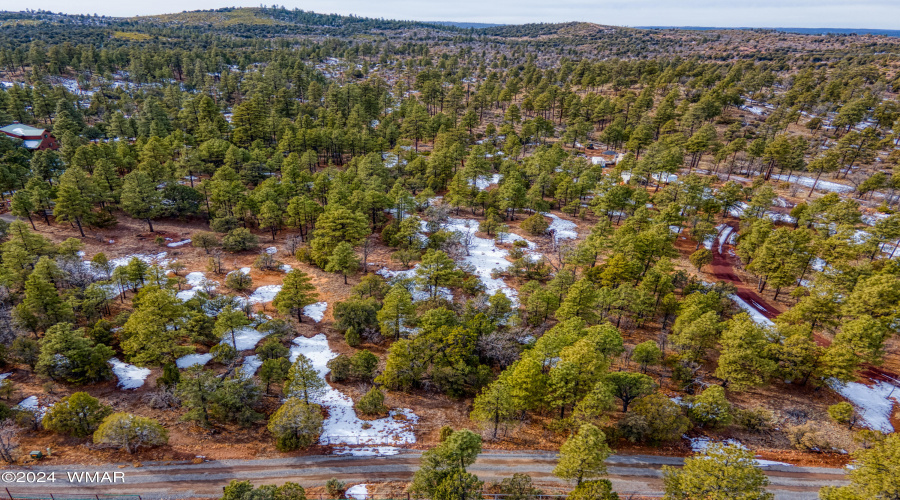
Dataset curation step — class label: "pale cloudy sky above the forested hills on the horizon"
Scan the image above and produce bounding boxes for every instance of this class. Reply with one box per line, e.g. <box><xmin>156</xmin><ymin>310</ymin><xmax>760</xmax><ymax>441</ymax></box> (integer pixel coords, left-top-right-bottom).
<box><xmin>12</xmin><ymin>0</ymin><xmax>900</xmax><ymax>29</ymax></box>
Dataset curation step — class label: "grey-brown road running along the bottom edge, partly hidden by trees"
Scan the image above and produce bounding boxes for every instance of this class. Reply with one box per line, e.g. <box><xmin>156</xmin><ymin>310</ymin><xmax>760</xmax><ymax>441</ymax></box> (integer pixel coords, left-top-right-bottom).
<box><xmin>0</xmin><ymin>450</ymin><xmax>846</xmax><ymax>500</ymax></box>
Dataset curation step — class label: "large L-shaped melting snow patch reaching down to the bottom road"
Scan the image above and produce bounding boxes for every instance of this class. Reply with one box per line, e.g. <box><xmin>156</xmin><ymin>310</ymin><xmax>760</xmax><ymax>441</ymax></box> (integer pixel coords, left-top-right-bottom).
<box><xmin>291</xmin><ymin>333</ymin><xmax>419</xmax><ymax>454</ymax></box>
